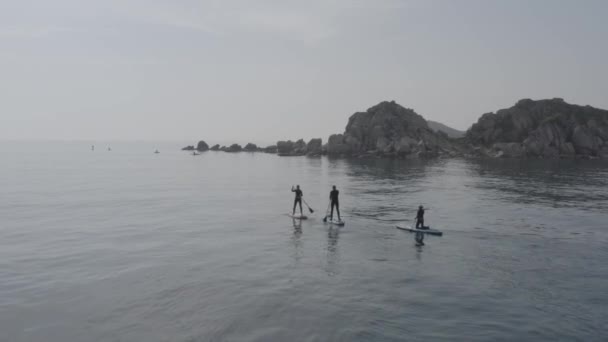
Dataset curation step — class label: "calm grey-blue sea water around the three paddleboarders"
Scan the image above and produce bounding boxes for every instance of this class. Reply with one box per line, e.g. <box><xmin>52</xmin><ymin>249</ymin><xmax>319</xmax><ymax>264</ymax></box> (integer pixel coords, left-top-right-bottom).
<box><xmin>0</xmin><ymin>142</ymin><xmax>608</xmax><ymax>342</ymax></box>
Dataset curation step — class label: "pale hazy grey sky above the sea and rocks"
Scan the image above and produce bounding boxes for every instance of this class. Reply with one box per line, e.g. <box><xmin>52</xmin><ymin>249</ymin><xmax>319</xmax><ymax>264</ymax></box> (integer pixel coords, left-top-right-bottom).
<box><xmin>0</xmin><ymin>0</ymin><xmax>608</xmax><ymax>143</ymax></box>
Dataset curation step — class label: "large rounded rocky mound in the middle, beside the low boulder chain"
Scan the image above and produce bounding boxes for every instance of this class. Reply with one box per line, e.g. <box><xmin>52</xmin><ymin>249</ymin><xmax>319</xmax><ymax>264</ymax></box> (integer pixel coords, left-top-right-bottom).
<box><xmin>326</xmin><ymin>101</ymin><xmax>459</xmax><ymax>158</ymax></box>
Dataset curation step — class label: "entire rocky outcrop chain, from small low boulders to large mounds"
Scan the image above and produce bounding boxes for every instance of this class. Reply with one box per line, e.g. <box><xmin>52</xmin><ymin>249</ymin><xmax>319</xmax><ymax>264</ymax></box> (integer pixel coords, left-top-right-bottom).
<box><xmin>182</xmin><ymin>98</ymin><xmax>608</xmax><ymax>159</ymax></box>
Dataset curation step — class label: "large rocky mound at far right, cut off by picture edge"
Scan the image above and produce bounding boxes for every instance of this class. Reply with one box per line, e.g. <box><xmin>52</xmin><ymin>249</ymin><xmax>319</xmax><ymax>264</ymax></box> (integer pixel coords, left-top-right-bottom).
<box><xmin>466</xmin><ymin>98</ymin><xmax>608</xmax><ymax>158</ymax></box>
